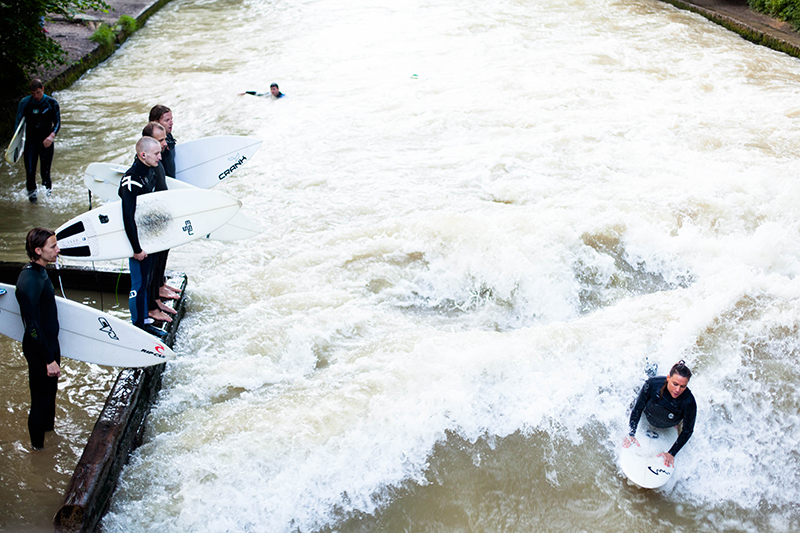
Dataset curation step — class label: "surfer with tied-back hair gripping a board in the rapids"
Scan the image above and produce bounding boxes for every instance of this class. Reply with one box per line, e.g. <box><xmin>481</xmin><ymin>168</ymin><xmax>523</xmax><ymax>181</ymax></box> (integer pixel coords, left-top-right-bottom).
<box><xmin>622</xmin><ymin>360</ymin><xmax>697</xmax><ymax>466</ymax></box>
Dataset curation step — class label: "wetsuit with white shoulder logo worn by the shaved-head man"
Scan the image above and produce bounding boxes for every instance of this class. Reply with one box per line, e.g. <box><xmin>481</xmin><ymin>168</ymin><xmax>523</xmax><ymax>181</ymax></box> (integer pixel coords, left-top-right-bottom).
<box><xmin>118</xmin><ymin>158</ymin><xmax>167</xmax><ymax>328</ymax></box>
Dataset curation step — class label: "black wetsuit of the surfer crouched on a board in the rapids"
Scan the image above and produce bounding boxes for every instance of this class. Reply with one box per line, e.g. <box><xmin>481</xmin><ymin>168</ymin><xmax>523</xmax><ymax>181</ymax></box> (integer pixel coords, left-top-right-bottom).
<box><xmin>630</xmin><ymin>376</ymin><xmax>697</xmax><ymax>457</ymax></box>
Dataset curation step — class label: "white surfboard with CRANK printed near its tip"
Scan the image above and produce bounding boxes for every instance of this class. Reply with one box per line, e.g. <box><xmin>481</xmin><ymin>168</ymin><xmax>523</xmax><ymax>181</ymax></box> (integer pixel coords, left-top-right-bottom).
<box><xmin>172</xmin><ymin>135</ymin><xmax>262</xmax><ymax>189</ymax></box>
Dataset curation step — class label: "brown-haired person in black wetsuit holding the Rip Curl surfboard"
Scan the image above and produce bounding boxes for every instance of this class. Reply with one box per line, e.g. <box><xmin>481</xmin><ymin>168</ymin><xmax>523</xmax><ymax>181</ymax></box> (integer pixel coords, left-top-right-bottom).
<box><xmin>14</xmin><ymin>228</ymin><xmax>61</xmax><ymax>450</ymax></box>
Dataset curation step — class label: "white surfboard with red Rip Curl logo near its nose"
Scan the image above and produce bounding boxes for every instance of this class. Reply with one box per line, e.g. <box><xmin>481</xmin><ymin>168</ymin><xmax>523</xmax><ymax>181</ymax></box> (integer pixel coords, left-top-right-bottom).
<box><xmin>0</xmin><ymin>283</ymin><xmax>175</xmax><ymax>368</ymax></box>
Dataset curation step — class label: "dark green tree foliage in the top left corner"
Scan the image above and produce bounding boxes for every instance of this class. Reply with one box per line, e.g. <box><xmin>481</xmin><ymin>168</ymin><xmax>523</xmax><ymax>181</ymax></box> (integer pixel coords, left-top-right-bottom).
<box><xmin>0</xmin><ymin>0</ymin><xmax>108</xmax><ymax>94</ymax></box>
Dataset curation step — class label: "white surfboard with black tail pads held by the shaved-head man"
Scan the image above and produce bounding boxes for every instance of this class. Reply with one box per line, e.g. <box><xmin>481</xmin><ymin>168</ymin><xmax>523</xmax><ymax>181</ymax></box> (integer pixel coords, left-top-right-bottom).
<box><xmin>56</xmin><ymin>189</ymin><xmax>242</xmax><ymax>261</ymax></box>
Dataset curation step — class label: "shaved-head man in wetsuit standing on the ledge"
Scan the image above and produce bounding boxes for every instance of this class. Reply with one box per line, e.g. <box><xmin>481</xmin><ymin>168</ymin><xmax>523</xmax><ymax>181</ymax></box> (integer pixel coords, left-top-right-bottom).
<box><xmin>118</xmin><ymin>137</ymin><xmax>167</xmax><ymax>336</ymax></box>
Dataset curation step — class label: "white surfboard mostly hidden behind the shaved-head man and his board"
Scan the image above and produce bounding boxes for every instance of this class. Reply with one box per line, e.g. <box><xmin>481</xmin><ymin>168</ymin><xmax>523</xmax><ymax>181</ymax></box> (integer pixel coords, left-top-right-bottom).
<box><xmin>83</xmin><ymin>163</ymin><xmax>263</xmax><ymax>241</ymax></box>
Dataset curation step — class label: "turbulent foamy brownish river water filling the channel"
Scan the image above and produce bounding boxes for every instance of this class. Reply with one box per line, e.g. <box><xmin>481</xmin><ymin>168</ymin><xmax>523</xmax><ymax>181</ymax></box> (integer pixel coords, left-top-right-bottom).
<box><xmin>0</xmin><ymin>0</ymin><xmax>800</xmax><ymax>533</ymax></box>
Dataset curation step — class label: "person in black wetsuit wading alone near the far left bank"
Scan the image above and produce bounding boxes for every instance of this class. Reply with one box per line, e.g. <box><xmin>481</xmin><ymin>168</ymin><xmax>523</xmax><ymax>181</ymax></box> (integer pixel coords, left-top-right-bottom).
<box><xmin>14</xmin><ymin>79</ymin><xmax>61</xmax><ymax>203</ymax></box>
